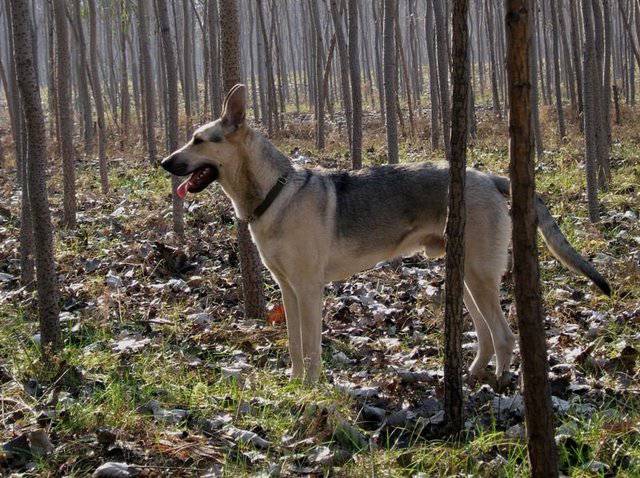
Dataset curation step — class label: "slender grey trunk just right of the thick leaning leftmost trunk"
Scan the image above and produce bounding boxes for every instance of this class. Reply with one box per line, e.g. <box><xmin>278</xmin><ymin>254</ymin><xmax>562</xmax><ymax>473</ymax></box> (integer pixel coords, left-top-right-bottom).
<box><xmin>53</xmin><ymin>0</ymin><xmax>76</xmax><ymax>228</ymax></box>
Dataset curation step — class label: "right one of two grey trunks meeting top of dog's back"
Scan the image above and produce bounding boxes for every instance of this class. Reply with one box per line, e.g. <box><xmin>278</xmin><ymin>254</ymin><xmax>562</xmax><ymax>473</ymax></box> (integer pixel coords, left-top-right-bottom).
<box><xmin>383</xmin><ymin>0</ymin><xmax>398</xmax><ymax>164</ymax></box>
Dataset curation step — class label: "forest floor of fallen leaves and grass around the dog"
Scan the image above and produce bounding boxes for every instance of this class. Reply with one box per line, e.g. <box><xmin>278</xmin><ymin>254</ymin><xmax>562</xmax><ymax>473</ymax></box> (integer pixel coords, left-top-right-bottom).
<box><xmin>0</xmin><ymin>106</ymin><xmax>640</xmax><ymax>477</ymax></box>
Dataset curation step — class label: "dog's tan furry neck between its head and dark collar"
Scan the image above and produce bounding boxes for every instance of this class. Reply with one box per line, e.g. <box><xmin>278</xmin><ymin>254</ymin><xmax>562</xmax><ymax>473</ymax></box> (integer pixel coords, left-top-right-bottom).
<box><xmin>221</xmin><ymin>127</ymin><xmax>293</xmax><ymax>219</ymax></box>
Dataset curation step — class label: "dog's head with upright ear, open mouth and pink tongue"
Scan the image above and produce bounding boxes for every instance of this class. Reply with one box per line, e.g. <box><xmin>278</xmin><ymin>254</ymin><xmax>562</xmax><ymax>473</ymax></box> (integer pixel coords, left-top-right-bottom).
<box><xmin>160</xmin><ymin>84</ymin><xmax>248</xmax><ymax>198</ymax></box>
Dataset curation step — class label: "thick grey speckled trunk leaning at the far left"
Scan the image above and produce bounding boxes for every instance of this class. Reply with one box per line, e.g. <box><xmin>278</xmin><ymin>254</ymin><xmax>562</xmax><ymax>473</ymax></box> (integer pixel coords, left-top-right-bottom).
<box><xmin>11</xmin><ymin>0</ymin><xmax>62</xmax><ymax>359</ymax></box>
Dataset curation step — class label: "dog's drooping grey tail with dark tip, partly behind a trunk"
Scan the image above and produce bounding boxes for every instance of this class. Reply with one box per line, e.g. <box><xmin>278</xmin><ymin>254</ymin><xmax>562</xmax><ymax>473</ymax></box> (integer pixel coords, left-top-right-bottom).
<box><xmin>491</xmin><ymin>176</ymin><xmax>611</xmax><ymax>296</ymax></box>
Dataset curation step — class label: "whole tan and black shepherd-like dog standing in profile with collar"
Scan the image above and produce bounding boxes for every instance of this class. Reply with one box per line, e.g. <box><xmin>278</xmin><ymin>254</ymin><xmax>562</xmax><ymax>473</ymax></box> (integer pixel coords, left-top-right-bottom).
<box><xmin>162</xmin><ymin>85</ymin><xmax>611</xmax><ymax>383</ymax></box>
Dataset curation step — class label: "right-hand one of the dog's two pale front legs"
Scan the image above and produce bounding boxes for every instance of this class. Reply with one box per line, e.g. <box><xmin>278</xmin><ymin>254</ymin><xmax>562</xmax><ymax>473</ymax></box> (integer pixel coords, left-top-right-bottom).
<box><xmin>296</xmin><ymin>284</ymin><xmax>323</xmax><ymax>385</ymax></box>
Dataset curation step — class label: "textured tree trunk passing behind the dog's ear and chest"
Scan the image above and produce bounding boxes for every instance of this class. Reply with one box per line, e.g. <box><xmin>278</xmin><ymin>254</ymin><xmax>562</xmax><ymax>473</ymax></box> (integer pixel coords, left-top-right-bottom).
<box><xmin>220</xmin><ymin>0</ymin><xmax>266</xmax><ymax>319</ymax></box>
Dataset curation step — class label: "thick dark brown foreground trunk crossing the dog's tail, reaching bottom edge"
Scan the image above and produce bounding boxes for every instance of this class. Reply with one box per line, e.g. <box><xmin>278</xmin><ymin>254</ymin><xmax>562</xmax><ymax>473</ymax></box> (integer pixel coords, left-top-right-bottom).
<box><xmin>506</xmin><ymin>0</ymin><xmax>558</xmax><ymax>477</ymax></box>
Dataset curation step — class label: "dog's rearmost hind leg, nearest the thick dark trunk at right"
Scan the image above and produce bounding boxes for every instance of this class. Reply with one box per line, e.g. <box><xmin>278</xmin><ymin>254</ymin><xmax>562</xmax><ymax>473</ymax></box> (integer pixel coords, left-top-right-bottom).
<box><xmin>465</xmin><ymin>268</ymin><xmax>516</xmax><ymax>380</ymax></box>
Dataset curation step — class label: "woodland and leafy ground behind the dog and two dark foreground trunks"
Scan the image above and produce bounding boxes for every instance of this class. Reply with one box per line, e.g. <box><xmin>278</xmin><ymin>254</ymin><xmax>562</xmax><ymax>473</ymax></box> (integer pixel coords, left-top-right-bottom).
<box><xmin>0</xmin><ymin>0</ymin><xmax>640</xmax><ymax>476</ymax></box>
